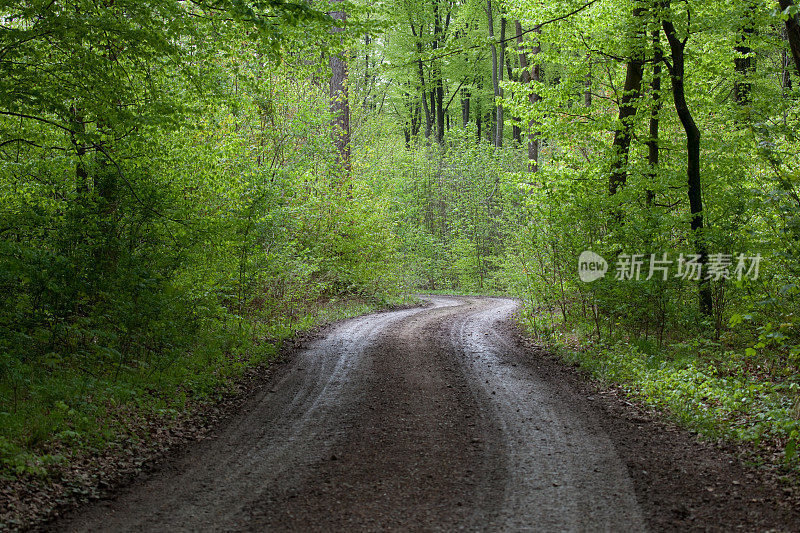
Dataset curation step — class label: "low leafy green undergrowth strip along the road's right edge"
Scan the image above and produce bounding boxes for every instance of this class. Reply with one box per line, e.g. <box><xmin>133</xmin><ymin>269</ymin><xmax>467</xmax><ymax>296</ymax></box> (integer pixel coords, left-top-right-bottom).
<box><xmin>520</xmin><ymin>310</ymin><xmax>800</xmax><ymax>476</ymax></box>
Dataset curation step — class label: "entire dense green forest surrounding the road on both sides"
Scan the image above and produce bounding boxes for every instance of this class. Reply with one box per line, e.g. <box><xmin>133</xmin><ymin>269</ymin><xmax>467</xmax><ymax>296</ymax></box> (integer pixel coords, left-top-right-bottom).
<box><xmin>0</xmin><ymin>0</ymin><xmax>800</xmax><ymax>508</ymax></box>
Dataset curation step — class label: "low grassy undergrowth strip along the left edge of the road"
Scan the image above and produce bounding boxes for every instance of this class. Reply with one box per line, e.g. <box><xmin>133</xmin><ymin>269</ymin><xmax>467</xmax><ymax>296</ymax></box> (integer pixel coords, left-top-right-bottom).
<box><xmin>0</xmin><ymin>298</ymin><xmax>410</xmax><ymax>479</ymax></box>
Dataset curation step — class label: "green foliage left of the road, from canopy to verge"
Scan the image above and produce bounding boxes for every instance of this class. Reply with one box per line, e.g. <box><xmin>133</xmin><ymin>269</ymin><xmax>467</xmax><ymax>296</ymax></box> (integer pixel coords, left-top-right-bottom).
<box><xmin>0</xmin><ymin>0</ymin><xmax>398</xmax><ymax>486</ymax></box>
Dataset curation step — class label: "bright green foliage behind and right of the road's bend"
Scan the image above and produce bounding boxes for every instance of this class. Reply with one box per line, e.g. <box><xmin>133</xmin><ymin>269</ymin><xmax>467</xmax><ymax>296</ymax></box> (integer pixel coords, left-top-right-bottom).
<box><xmin>356</xmin><ymin>0</ymin><xmax>800</xmax><ymax>470</ymax></box>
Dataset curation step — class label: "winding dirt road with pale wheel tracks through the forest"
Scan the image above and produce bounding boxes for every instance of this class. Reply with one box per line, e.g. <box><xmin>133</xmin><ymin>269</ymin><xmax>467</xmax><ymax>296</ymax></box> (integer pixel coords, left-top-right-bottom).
<box><xmin>50</xmin><ymin>297</ymin><xmax>800</xmax><ymax>531</ymax></box>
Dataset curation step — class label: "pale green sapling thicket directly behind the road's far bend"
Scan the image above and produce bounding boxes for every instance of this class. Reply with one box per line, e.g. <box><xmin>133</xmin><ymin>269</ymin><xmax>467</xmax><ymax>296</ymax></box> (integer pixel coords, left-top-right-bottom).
<box><xmin>357</xmin><ymin>125</ymin><xmax>523</xmax><ymax>292</ymax></box>
